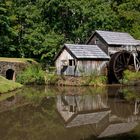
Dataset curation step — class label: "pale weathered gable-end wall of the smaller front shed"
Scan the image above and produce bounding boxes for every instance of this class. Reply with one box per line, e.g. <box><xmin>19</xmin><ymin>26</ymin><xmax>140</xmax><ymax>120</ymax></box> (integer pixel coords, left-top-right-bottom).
<box><xmin>55</xmin><ymin>49</ymin><xmax>74</xmax><ymax>75</ymax></box>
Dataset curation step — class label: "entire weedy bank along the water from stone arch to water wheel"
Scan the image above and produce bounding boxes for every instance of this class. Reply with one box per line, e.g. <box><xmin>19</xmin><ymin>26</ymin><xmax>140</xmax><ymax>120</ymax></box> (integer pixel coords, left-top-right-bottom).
<box><xmin>17</xmin><ymin>65</ymin><xmax>107</xmax><ymax>86</ymax></box>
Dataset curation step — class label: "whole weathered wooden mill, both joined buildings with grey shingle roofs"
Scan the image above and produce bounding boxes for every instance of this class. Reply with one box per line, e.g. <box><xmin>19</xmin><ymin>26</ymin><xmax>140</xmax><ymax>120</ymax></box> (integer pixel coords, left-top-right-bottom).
<box><xmin>55</xmin><ymin>30</ymin><xmax>140</xmax><ymax>76</ymax></box>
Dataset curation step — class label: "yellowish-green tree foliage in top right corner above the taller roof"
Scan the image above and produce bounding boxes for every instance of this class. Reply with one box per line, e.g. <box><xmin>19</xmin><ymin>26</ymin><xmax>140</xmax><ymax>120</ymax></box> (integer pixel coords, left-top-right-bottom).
<box><xmin>112</xmin><ymin>0</ymin><xmax>140</xmax><ymax>39</ymax></box>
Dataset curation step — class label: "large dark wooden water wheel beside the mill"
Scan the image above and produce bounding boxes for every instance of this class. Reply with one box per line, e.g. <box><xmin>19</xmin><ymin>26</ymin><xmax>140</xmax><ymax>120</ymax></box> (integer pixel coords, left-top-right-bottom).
<box><xmin>108</xmin><ymin>51</ymin><xmax>134</xmax><ymax>83</ymax></box>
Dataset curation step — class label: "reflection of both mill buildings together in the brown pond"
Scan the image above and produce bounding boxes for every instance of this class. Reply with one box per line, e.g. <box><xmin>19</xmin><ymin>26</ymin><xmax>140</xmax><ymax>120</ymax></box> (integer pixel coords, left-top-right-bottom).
<box><xmin>57</xmin><ymin>94</ymin><xmax>139</xmax><ymax>137</ymax></box>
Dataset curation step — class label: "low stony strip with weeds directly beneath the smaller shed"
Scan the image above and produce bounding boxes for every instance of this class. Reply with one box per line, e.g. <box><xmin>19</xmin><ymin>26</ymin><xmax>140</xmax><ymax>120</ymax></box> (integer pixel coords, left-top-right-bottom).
<box><xmin>45</xmin><ymin>73</ymin><xmax>107</xmax><ymax>86</ymax></box>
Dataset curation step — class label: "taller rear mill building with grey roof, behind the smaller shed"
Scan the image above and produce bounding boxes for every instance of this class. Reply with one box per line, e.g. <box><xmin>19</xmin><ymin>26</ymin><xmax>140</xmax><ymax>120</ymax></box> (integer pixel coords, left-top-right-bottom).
<box><xmin>86</xmin><ymin>30</ymin><xmax>140</xmax><ymax>55</ymax></box>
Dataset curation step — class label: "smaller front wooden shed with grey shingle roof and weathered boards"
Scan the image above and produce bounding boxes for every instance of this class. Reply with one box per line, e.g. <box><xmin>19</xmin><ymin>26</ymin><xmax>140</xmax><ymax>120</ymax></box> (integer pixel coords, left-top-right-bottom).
<box><xmin>55</xmin><ymin>44</ymin><xmax>110</xmax><ymax>76</ymax></box>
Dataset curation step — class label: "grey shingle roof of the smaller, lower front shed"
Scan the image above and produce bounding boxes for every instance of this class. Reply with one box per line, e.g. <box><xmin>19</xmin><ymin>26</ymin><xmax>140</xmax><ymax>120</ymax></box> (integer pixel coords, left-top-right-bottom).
<box><xmin>65</xmin><ymin>44</ymin><xmax>110</xmax><ymax>59</ymax></box>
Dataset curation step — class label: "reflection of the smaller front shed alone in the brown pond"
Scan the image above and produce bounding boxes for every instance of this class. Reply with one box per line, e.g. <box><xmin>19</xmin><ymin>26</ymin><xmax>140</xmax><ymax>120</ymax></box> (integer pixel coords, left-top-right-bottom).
<box><xmin>57</xmin><ymin>94</ymin><xmax>110</xmax><ymax>127</ymax></box>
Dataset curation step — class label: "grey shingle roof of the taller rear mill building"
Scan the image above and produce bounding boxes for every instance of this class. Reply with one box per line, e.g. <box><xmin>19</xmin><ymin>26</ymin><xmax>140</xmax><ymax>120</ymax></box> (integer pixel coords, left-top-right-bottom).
<box><xmin>88</xmin><ymin>30</ymin><xmax>138</xmax><ymax>45</ymax></box>
